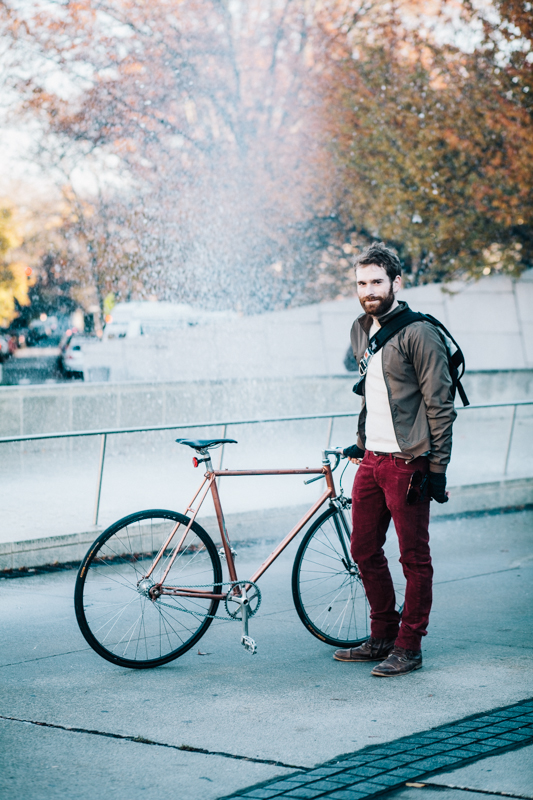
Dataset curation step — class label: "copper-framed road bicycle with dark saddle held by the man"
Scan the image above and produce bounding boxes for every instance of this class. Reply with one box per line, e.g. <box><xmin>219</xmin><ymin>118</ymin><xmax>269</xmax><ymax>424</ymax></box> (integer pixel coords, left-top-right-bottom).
<box><xmin>74</xmin><ymin>439</ymin><xmax>382</xmax><ymax>669</ymax></box>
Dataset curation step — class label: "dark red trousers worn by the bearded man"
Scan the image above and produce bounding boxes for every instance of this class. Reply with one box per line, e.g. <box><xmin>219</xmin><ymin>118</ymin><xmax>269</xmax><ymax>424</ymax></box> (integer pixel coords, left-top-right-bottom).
<box><xmin>351</xmin><ymin>450</ymin><xmax>433</xmax><ymax>650</ymax></box>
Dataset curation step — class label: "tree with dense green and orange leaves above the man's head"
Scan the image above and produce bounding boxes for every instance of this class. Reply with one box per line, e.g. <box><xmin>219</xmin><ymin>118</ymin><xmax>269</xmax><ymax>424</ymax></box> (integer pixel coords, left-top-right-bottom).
<box><xmin>318</xmin><ymin>3</ymin><xmax>533</xmax><ymax>283</ymax></box>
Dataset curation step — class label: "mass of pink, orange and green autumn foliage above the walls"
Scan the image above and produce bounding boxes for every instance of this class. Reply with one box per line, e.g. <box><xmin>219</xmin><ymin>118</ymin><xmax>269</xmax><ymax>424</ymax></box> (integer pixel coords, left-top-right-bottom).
<box><xmin>3</xmin><ymin>0</ymin><xmax>533</xmax><ymax>312</ymax></box>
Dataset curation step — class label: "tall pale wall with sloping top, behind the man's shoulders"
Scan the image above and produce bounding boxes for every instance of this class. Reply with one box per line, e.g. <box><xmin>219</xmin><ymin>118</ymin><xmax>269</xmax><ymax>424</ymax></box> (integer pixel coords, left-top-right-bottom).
<box><xmin>79</xmin><ymin>270</ymin><xmax>533</xmax><ymax>382</ymax></box>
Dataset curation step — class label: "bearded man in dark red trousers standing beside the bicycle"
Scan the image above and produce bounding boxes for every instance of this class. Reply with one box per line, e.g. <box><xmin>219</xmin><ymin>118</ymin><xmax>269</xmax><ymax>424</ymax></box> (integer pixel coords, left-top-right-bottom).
<box><xmin>334</xmin><ymin>243</ymin><xmax>456</xmax><ymax>677</ymax></box>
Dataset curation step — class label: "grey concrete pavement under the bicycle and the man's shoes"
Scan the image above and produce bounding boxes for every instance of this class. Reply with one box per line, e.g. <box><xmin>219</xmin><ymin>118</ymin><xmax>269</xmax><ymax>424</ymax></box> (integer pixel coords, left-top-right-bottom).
<box><xmin>0</xmin><ymin>511</ymin><xmax>533</xmax><ymax>800</ymax></box>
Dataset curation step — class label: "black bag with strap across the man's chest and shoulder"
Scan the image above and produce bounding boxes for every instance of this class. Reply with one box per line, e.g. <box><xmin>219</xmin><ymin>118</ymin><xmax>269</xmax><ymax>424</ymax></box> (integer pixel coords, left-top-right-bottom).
<box><xmin>353</xmin><ymin>308</ymin><xmax>470</xmax><ymax>406</ymax></box>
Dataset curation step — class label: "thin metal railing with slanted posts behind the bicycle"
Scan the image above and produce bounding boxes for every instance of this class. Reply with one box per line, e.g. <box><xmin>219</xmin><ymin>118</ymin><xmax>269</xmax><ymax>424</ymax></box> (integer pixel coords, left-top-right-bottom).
<box><xmin>0</xmin><ymin>400</ymin><xmax>533</xmax><ymax>525</ymax></box>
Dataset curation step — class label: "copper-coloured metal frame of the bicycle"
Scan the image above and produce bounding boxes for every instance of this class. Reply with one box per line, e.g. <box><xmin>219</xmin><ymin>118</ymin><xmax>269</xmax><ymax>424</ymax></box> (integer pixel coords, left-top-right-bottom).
<box><xmin>144</xmin><ymin>459</ymin><xmax>337</xmax><ymax>600</ymax></box>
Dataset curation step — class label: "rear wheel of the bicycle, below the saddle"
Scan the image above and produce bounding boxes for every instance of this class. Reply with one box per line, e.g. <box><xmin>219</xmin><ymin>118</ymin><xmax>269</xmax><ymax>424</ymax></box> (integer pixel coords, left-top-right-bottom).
<box><xmin>74</xmin><ymin>509</ymin><xmax>222</xmax><ymax>669</ymax></box>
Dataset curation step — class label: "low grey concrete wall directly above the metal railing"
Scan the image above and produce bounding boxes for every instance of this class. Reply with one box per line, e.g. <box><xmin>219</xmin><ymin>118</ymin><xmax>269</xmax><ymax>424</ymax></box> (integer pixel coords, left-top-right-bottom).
<box><xmin>0</xmin><ymin>369</ymin><xmax>533</xmax><ymax>438</ymax></box>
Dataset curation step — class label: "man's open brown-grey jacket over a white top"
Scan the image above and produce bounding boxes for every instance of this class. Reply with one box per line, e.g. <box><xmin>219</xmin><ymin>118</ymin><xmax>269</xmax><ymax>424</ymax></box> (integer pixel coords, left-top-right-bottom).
<box><xmin>351</xmin><ymin>301</ymin><xmax>457</xmax><ymax>472</ymax></box>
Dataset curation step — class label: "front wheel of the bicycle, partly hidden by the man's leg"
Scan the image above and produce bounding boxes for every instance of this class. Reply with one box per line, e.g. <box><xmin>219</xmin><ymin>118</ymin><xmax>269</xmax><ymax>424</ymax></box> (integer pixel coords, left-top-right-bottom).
<box><xmin>292</xmin><ymin>507</ymin><xmax>370</xmax><ymax>647</ymax></box>
